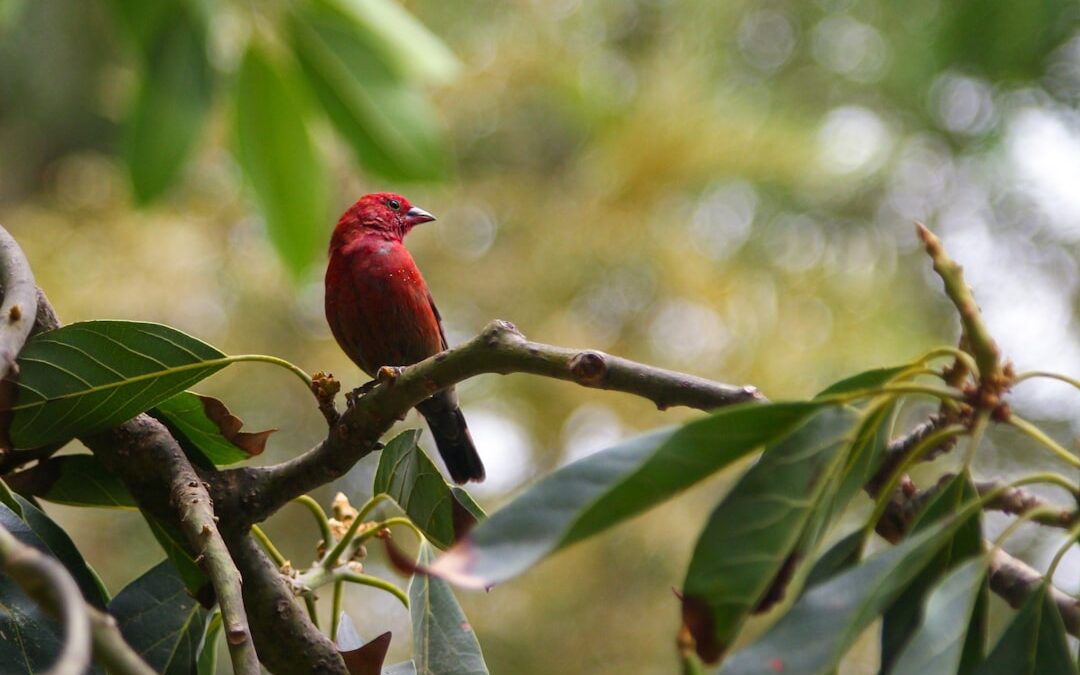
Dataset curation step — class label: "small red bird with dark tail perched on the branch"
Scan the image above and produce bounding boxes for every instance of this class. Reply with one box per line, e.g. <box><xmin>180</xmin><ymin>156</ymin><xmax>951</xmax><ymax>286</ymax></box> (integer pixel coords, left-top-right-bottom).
<box><xmin>326</xmin><ymin>192</ymin><xmax>484</xmax><ymax>483</ymax></box>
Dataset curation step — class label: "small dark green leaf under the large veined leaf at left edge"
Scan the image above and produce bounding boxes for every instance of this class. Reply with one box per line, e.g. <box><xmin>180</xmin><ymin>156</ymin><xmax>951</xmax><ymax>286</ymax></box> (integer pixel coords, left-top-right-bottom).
<box><xmin>4</xmin><ymin>455</ymin><xmax>136</xmax><ymax>509</ymax></box>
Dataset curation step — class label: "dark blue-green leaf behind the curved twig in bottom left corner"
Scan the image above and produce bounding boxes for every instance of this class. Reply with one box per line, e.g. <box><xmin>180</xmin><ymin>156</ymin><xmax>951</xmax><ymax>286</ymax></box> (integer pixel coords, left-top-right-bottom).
<box><xmin>0</xmin><ymin>496</ymin><xmax>108</xmax><ymax>675</ymax></box>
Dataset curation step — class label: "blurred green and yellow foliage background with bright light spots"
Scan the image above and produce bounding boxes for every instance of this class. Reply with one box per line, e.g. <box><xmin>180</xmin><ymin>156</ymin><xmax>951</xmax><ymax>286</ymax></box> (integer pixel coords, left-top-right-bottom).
<box><xmin>0</xmin><ymin>0</ymin><xmax>1080</xmax><ymax>675</ymax></box>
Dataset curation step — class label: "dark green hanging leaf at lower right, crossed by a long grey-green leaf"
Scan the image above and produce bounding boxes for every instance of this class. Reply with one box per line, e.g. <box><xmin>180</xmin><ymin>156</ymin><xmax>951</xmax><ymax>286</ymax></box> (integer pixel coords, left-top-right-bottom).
<box><xmin>881</xmin><ymin>473</ymin><xmax>983</xmax><ymax>671</ymax></box>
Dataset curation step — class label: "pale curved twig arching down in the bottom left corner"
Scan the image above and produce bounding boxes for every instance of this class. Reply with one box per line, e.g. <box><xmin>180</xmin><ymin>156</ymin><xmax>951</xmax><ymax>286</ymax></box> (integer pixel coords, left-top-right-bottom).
<box><xmin>0</xmin><ymin>520</ymin><xmax>91</xmax><ymax>675</ymax></box>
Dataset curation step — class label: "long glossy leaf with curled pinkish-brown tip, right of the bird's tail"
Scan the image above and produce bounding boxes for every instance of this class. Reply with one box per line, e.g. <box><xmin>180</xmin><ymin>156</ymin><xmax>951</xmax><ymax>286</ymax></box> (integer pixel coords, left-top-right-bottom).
<box><xmin>433</xmin><ymin>402</ymin><xmax>824</xmax><ymax>588</ymax></box>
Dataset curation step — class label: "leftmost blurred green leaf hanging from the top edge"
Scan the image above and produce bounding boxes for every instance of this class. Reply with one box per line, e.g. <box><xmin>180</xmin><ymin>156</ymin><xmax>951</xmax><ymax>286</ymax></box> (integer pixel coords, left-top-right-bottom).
<box><xmin>125</xmin><ymin>2</ymin><xmax>214</xmax><ymax>204</ymax></box>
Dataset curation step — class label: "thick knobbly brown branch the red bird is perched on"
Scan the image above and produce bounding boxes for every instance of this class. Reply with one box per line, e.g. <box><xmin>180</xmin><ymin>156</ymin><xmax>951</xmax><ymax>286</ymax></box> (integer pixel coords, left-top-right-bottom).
<box><xmin>212</xmin><ymin>321</ymin><xmax>762</xmax><ymax>523</ymax></box>
